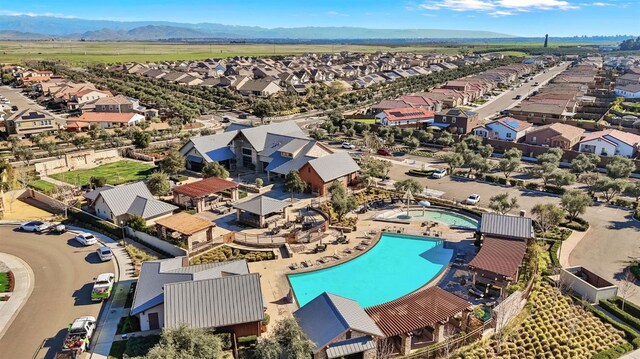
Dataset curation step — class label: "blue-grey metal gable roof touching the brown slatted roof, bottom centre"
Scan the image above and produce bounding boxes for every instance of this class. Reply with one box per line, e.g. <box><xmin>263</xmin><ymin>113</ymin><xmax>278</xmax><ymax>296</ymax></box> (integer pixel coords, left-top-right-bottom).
<box><xmin>293</xmin><ymin>292</ymin><xmax>384</xmax><ymax>352</ymax></box>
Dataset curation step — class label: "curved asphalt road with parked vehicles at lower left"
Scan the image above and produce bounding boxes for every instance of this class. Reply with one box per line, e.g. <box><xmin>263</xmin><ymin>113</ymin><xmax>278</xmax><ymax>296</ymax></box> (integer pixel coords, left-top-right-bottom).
<box><xmin>0</xmin><ymin>226</ymin><xmax>114</xmax><ymax>358</ymax></box>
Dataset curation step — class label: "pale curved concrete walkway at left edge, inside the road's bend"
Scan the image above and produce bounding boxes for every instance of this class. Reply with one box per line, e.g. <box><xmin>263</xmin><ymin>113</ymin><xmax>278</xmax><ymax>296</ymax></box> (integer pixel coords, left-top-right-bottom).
<box><xmin>0</xmin><ymin>253</ymin><xmax>35</xmax><ymax>344</ymax></box>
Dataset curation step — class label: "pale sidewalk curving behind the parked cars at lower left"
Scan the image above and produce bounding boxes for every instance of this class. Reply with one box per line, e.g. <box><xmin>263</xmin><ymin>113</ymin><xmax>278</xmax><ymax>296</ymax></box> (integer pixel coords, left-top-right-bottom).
<box><xmin>68</xmin><ymin>226</ymin><xmax>135</xmax><ymax>359</ymax></box>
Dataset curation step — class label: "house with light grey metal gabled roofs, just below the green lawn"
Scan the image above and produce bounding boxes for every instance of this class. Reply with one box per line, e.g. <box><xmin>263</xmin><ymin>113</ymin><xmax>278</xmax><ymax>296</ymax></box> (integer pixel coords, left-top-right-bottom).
<box><xmin>85</xmin><ymin>181</ymin><xmax>178</xmax><ymax>225</ymax></box>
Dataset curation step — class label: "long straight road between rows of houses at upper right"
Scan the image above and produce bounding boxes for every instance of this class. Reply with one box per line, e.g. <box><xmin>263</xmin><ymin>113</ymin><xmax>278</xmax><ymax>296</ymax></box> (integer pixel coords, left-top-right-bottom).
<box><xmin>473</xmin><ymin>62</ymin><xmax>569</xmax><ymax>120</ymax></box>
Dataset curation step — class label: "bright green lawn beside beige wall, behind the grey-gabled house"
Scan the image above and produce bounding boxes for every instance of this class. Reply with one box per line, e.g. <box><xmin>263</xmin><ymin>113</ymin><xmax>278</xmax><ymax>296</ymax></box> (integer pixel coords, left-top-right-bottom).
<box><xmin>51</xmin><ymin>160</ymin><xmax>154</xmax><ymax>186</ymax></box>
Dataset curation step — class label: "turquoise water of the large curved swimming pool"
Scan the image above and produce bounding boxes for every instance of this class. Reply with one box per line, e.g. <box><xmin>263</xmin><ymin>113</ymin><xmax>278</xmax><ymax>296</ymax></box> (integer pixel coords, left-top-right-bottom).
<box><xmin>289</xmin><ymin>233</ymin><xmax>453</xmax><ymax>308</ymax></box>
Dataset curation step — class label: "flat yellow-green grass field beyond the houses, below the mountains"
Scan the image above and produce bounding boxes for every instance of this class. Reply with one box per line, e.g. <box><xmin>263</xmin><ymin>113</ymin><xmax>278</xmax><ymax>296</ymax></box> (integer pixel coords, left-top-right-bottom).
<box><xmin>0</xmin><ymin>39</ymin><xmax>580</xmax><ymax>65</ymax></box>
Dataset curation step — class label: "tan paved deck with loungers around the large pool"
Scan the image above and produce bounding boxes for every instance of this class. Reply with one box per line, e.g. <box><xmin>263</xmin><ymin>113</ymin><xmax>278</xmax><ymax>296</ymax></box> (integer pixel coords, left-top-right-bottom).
<box><xmin>249</xmin><ymin>213</ymin><xmax>475</xmax><ymax>331</ymax></box>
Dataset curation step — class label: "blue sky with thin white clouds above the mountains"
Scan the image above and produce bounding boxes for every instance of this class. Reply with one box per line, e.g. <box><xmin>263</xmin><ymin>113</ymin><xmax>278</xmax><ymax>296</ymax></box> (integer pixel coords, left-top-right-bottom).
<box><xmin>0</xmin><ymin>0</ymin><xmax>640</xmax><ymax>37</ymax></box>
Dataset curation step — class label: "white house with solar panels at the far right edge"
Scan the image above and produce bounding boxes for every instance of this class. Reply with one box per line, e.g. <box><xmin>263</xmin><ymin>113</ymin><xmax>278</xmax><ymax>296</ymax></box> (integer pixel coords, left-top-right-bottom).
<box><xmin>578</xmin><ymin>129</ymin><xmax>640</xmax><ymax>158</ymax></box>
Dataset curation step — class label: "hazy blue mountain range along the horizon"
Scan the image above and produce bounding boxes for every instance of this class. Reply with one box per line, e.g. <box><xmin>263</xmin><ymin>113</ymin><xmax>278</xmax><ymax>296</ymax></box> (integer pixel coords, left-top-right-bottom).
<box><xmin>0</xmin><ymin>15</ymin><xmax>513</xmax><ymax>41</ymax></box>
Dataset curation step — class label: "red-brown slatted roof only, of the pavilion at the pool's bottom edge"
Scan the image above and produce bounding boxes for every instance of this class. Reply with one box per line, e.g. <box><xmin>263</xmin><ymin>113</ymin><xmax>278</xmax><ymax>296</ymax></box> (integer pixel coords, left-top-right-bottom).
<box><xmin>365</xmin><ymin>287</ymin><xmax>472</xmax><ymax>337</ymax></box>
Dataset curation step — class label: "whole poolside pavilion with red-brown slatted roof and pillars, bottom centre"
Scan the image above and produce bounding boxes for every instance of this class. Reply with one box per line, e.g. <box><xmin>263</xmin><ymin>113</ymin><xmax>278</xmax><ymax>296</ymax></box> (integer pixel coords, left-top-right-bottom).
<box><xmin>365</xmin><ymin>287</ymin><xmax>473</xmax><ymax>356</ymax></box>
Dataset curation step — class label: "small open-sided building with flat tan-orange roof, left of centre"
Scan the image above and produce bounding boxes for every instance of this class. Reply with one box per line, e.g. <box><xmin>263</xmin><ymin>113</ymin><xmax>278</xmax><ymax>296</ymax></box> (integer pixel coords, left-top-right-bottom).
<box><xmin>156</xmin><ymin>212</ymin><xmax>216</xmax><ymax>252</ymax></box>
